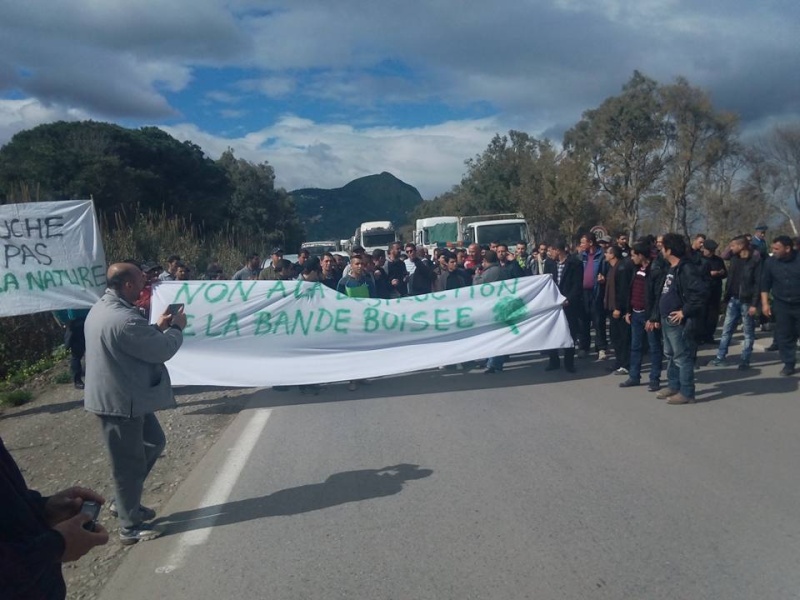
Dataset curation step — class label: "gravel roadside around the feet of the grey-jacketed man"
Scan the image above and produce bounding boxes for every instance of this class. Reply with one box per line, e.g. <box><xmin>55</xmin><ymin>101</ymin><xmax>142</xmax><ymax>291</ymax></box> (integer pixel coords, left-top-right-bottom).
<box><xmin>0</xmin><ymin>375</ymin><xmax>255</xmax><ymax>600</ymax></box>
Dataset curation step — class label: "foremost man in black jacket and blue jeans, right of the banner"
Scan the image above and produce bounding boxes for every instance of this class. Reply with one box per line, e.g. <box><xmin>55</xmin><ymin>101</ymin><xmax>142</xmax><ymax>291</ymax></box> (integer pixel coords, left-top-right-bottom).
<box><xmin>656</xmin><ymin>233</ymin><xmax>709</xmax><ymax>404</ymax></box>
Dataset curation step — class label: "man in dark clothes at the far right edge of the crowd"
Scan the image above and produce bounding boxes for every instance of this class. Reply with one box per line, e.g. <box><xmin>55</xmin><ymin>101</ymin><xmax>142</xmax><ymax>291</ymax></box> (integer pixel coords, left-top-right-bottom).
<box><xmin>761</xmin><ymin>235</ymin><xmax>800</xmax><ymax>376</ymax></box>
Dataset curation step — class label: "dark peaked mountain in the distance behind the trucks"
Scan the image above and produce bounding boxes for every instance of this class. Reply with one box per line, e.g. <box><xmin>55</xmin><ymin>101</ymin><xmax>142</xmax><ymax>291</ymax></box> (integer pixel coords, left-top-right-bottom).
<box><xmin>290</xmin><ymin>172</ymin><xmax>422</xmax><ymax>240</ymax></box>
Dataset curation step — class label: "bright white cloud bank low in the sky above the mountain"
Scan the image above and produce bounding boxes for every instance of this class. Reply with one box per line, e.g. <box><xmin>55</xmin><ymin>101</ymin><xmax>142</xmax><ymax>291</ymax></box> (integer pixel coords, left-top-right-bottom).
<box><xmin>162</xmin><ymin>115</ymin><xmax>507</xmax><ymax>198</ymax></box>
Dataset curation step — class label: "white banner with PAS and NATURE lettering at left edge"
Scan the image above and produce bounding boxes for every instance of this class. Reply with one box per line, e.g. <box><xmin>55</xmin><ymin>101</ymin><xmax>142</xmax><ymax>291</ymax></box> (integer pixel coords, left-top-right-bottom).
<box><xmin>0</xmin><ymin>200</ymin><xmax>106</xmax><ymax>317</ymax></box>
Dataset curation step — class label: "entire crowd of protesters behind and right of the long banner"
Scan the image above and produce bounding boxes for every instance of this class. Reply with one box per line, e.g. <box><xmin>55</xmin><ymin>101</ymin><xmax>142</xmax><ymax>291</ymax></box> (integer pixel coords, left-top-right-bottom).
<box><xmin>128</xmin><ymin>226</ymin><xmax>800</xmax><ymax>404</ymax></box>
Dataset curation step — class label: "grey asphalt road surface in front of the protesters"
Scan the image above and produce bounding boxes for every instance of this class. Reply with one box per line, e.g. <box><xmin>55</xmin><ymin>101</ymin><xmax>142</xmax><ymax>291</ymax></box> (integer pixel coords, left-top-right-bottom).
<box><xmin>98</xmin><ymin>347</ymin><xmax>800</xmax><ymax>600</ymax></box>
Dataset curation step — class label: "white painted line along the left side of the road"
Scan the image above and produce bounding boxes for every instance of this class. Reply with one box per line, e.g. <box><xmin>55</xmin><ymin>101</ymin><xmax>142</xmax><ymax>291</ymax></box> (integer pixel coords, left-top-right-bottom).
<box><xmin>156</xmin><ymin>408</ymin><xmax>272</xmax><ymax>573</ymax></box>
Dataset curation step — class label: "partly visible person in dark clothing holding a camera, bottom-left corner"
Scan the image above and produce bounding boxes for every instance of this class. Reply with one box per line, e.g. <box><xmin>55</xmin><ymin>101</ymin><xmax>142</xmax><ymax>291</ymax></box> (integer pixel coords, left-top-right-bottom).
<box><xmin>0</xmin><ymin>439</ymin><xmax>108</xmax><ymax>600</ymax></box>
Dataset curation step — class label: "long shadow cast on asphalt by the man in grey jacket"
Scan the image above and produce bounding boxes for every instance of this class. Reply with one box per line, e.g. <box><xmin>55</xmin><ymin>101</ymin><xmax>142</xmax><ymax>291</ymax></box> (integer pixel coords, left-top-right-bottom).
<box><xmin>153</xmin><ymin>464</ymin><xmax>433</xmax><ymax>535</ymax></box>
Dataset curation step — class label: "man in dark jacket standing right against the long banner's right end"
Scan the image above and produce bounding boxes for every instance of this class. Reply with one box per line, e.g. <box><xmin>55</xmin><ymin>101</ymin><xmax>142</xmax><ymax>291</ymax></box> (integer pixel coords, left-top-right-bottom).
<box><xmin>544</xmin><ymin>239</ymin><xmax>583</xmax><ymax>373</ymax></box>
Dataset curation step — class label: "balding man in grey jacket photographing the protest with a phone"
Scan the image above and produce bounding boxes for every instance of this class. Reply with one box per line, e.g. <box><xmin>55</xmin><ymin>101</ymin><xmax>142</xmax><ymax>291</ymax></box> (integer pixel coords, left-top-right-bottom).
<box><xmin>84</xmin><ymin>263</ymin><xmax>186</xmax><ymax>545</ymax></box>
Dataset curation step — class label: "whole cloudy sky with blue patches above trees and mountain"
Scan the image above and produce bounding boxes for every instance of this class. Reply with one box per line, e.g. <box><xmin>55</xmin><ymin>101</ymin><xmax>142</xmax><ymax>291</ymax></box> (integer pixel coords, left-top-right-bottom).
<box><xmin>0</xmin><ymin>0</ymin><xmax>800</xmax><ymax>198</ymax></box>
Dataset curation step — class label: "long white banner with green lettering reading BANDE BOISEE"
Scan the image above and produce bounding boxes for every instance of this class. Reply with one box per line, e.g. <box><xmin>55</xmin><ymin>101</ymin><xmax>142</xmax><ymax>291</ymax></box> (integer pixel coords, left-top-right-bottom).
<box><xmin>151</xmin><ymin>275</ymin><xmax>572</xmax><ymax>387</ymax></box>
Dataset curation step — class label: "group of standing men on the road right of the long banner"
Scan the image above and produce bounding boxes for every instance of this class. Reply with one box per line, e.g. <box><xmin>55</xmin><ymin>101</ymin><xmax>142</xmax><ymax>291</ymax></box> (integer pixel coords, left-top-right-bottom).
<box><xmin>543</xmin><ymin>227</ymin><xmax>800</xmax><ymax>404</ymax></box>
